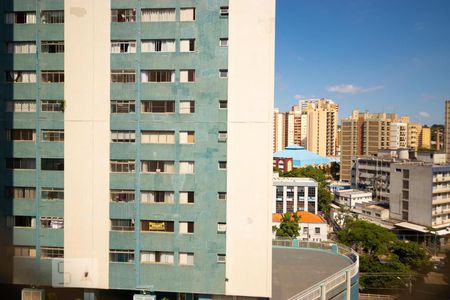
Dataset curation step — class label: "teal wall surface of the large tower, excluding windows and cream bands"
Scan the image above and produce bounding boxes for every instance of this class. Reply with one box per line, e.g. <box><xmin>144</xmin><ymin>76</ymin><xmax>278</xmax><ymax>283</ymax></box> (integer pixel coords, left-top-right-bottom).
<box><xmin>0</xmin><ymin>0</ymin><xmax>228</xmax><ymax>294</ymax></box>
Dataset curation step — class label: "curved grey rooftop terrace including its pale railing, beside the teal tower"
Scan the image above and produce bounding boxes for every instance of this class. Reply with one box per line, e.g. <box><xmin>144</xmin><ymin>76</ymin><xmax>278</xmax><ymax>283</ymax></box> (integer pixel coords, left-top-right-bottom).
<box><xmin>272</xmin><ymin>240</ymin><xmax>359</xmax><ymax>300</ymax></box>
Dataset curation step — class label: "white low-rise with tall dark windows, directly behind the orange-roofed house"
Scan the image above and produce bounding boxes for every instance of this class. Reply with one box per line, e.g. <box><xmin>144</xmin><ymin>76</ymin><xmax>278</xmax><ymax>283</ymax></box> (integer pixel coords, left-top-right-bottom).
<box><xmin>272</xmin><ymin>173</ymin><xmax>318</xmax><ymax>214</ymax></box>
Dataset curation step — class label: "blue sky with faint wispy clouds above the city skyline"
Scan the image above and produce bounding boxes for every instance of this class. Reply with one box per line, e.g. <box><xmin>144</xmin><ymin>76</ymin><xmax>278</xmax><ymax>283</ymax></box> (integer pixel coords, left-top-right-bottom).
<box><xmin>275</xmin><ymin>0</ymin><xmax>450</xmax><ymax>125</ymax></box>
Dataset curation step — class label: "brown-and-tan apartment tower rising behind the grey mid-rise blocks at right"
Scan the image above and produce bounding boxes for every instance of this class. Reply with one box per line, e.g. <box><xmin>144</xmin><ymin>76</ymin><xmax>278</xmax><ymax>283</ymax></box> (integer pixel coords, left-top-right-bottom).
<box><xmin>340</xmin><ymin>110</ymin><xmax>400</xmax><ymax>182</ymax></box>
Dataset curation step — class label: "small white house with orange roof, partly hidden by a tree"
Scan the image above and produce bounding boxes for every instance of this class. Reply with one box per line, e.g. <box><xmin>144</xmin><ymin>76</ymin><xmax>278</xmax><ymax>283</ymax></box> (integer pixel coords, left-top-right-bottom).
<box><xmin>272</xmin><ymin>211</ymin><xmax>328</xmax><ymax>242</ymax></box>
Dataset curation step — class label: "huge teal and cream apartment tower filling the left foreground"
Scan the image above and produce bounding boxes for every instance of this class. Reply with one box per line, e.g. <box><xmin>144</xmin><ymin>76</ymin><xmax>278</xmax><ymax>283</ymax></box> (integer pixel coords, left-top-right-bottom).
<box><xmin>0</xmin><ymin>0</ymin><xmax>275</xmax><ymax>299</ymax></box>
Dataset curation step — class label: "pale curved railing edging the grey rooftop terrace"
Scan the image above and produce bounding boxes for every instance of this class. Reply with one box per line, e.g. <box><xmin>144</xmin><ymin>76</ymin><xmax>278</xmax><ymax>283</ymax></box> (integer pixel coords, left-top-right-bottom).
<box><xmin>272</xmin><ymin>239</ymin><xmax>359</xmax><ymax>300</ymax></box>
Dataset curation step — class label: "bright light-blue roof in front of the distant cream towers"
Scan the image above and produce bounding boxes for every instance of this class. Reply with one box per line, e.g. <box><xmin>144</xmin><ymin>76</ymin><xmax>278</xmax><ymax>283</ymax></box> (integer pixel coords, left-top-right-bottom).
<box><xmin>273</xmin><ymin>145</ymin><xmax>331</xmax><ymax>168</ymax></box>
